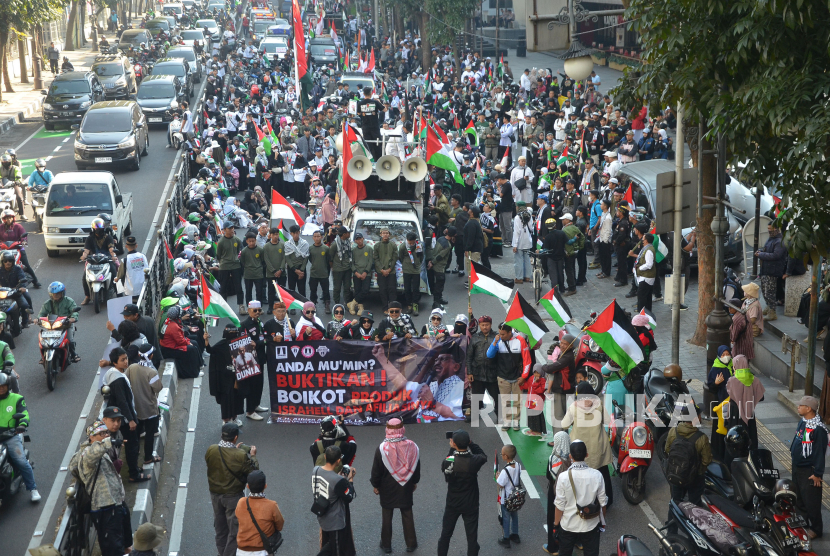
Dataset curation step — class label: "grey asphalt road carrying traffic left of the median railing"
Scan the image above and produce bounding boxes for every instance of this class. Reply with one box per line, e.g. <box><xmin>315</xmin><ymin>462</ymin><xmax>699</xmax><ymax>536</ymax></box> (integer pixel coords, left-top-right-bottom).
<box><xmin>0</xmin><ymin>75</ymin><xmax>201</xmax><ymax>555</ymax></box>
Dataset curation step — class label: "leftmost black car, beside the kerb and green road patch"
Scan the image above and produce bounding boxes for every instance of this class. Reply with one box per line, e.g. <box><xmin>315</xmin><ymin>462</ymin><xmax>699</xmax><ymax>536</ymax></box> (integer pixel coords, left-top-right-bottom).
<box><xmin>41</xmin><ymin>71</ymin><xmax>104</xmax><ymax>131</ymax></box>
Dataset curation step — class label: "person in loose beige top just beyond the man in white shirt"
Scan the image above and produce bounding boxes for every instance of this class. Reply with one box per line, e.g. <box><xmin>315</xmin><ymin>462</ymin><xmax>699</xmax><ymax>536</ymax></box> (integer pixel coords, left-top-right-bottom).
<box><xmin>562</xmin><ymin>381</ymin><xmax>614</xmax><ymax>507</ymax></box>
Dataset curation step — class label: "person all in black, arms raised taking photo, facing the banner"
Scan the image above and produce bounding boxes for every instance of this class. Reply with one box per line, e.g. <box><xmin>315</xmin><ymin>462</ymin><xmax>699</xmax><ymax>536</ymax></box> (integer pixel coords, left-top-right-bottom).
<box><xmin>438</xmin><ymin>430</ymin><xmax>487</xmax><ymax>556</ymax></box>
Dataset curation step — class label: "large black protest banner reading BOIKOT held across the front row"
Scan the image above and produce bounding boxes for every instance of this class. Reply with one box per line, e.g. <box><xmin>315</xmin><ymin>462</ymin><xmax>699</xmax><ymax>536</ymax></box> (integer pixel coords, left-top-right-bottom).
<box><xmin>268</xmin><ymin>336</ymin><xmax>470</xmax><ymax>424</ymax></box>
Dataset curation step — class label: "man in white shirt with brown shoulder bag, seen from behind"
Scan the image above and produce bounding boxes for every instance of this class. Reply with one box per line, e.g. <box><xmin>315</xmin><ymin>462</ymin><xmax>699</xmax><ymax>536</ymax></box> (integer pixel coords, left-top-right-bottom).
<box><xmin>553</xmin><ymin>439</ymin><xmax>608</xmax><ymax>556</ymax></box>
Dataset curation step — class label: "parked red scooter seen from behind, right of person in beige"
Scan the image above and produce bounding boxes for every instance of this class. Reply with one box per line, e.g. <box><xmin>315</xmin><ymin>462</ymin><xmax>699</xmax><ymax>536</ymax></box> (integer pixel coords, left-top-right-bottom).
<box><xmin>610</xmin><ymin>401</ymin><xmax>654</xmax><ymax>504</ymax></box>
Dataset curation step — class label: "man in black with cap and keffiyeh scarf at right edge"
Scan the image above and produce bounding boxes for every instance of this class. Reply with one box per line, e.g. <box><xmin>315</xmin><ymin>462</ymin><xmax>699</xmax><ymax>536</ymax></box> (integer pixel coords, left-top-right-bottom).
<box><xmin>790</xmin><ymin>396</ymin><xmax>828</xmax><ymax>539</ymax></box>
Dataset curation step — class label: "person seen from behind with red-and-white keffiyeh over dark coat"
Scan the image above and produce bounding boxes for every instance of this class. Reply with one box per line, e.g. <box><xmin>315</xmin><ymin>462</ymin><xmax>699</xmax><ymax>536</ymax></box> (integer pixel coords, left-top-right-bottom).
<box><xmin>369</xmin><ymin>418</ymin><xmax>421</xmax><ymax>554</ymax></box>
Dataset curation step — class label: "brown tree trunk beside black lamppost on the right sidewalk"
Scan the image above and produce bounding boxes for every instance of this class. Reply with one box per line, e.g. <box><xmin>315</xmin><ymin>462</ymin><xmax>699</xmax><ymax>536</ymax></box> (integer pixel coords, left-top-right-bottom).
<box><xmin>689</xmin><ymin>124</ymin><xmax>717</xmax><ymax>346</ymax></box>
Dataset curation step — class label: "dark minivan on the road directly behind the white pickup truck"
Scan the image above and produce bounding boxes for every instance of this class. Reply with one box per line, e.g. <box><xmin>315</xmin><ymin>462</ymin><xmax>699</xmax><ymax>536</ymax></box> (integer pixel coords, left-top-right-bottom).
<box><xmin>72</xmin><ymin>100</ymin><xmax>150</xmax><ymax>170</ymax></box>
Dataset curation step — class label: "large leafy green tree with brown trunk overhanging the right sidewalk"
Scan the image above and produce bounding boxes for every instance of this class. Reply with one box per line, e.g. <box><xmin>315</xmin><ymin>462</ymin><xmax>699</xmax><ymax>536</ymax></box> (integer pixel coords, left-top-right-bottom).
<box><xmin>614</xmin><ymin>0</ymin><xmax>830</xmax><ymax>344</ymax></box>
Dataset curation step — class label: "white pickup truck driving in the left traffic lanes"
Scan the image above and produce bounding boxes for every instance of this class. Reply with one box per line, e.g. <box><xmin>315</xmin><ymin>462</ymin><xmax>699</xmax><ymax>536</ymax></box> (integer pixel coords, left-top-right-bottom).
<box><xmin>43</xmin><ymin>172</ymin><xmax>133</xmax><ymax>257</ymax></box>
